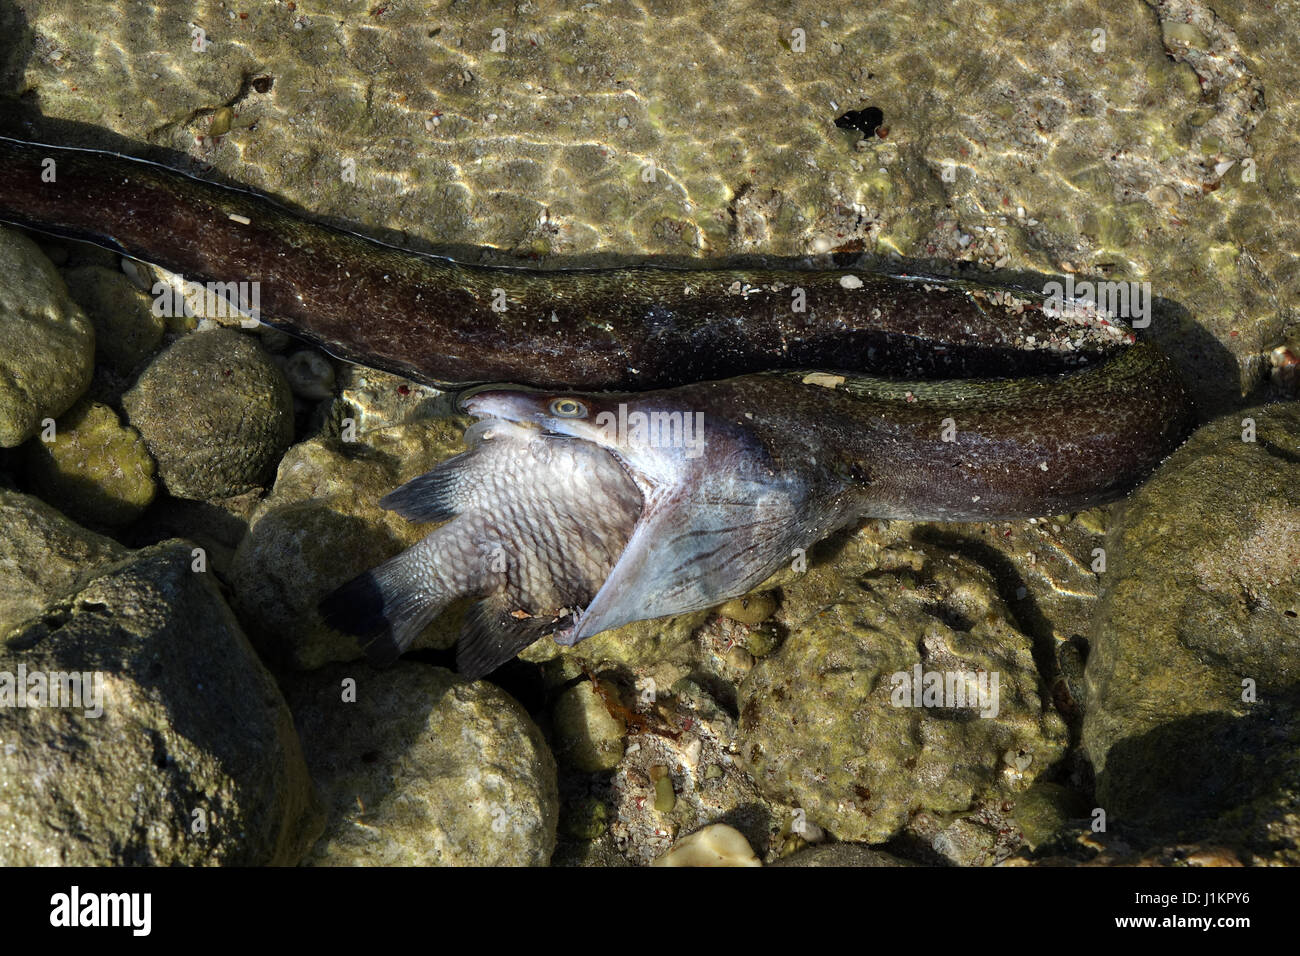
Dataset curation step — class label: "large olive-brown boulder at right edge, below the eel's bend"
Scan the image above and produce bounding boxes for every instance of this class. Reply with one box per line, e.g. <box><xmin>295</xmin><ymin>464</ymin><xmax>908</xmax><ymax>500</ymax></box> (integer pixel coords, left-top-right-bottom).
<box><xmin>1083</xmin><ymin>403</ymin><xmax>1300</xmax><ymax>862</ymax></box>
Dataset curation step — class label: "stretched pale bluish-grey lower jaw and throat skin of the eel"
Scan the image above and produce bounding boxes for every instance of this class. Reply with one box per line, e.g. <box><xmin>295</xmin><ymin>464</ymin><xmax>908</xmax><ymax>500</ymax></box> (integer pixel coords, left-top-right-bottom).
<box><xmin>572</xmin><ymin>486</ymin><xmax>800</xmax><ymax>645</ymax></box>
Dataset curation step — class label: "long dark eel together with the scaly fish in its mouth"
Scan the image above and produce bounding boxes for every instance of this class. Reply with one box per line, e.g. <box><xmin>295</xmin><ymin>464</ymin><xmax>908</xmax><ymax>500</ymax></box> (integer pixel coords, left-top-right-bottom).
<box><xmin>0</xmin><ymin>138</ymin><xmax>1193</xmax><ymax>676</ymax></box>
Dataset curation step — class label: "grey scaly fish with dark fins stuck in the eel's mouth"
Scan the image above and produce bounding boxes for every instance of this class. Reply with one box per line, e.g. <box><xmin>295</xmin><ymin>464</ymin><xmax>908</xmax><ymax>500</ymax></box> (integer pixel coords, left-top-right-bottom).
<box><xmin>320</xmin><ymin>419</ymin><xmax>642</xmax><ymax>678</ymax></box>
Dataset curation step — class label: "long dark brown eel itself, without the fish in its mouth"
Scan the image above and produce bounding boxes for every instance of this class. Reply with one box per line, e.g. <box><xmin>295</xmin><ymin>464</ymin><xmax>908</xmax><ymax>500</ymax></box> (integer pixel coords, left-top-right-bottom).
<box><xmin>0</xmin><ymin>138</ymin><xmax>1192</xmax><ymax>671</ymax></box>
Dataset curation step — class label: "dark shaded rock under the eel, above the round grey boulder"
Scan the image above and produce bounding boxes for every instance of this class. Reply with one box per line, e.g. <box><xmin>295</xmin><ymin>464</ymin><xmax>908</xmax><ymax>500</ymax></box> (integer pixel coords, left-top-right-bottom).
<box><xmin>64</xmin><ymin>265</ymin><xmax>166</xmax><ymax>375</ymax></box>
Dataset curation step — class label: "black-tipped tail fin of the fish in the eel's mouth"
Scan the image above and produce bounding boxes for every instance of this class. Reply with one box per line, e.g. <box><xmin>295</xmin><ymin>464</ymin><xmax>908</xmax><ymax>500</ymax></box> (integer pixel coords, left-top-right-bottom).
<box><xmin>317</xmin><ymin>551</ymin><xmax>452</xmax><ymax>665</ymax></box>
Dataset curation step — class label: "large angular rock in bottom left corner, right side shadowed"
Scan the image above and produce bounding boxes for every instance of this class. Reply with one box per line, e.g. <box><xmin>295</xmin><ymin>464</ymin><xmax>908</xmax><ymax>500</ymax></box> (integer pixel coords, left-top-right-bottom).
<box><xmin>0</xmin><ymin>541</ymin><xmax>320</xmax><ymax>866</ymax></box>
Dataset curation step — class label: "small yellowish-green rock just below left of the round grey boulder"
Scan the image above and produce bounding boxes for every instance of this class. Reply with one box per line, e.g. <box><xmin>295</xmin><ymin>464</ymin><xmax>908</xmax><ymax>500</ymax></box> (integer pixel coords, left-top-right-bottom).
<box><xmin>26</xmin><ymin>399</ymin><xmax>157</xmax><ymax>528</ymax></box>
